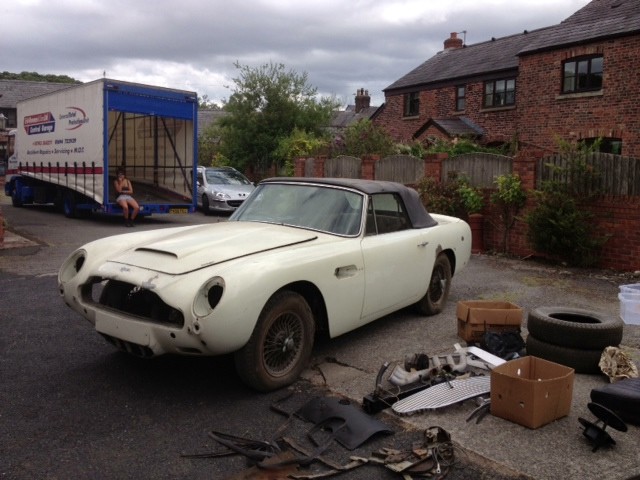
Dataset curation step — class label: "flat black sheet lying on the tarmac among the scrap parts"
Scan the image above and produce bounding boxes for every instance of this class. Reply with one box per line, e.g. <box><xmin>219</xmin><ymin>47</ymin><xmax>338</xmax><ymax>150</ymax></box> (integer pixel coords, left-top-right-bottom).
<box><xmin>296</xmin><ymin>397</ymin><xmax>394</xmax><ymax>450</ymax></box>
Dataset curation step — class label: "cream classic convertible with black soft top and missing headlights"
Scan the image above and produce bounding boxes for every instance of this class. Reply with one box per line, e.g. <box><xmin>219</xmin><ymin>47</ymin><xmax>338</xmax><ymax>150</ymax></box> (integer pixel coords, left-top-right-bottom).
<box><xmin>58</xmin><ymin>178</ymin><xmax>471</xmax><ymax>391</ymax></box>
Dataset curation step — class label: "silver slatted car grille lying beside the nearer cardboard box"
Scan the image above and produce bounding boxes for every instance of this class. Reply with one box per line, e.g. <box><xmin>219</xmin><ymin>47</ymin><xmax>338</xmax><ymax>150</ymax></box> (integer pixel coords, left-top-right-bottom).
<box><xmin>391</xmin><ymin>376</ymin><xmax>491</xmax><ymax>415</ymax></box>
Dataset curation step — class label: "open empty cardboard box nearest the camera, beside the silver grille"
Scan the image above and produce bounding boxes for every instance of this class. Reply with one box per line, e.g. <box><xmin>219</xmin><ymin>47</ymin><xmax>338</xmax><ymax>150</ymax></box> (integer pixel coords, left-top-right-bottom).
<box><xmin>491</xmin><ymin>356</ymin><xmax>574</xmax><ymax>428</ymax></box>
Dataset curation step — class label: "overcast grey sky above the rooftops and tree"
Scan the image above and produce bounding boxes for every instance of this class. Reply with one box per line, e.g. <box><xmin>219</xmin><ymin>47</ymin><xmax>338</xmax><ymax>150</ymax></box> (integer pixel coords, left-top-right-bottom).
<box><xmin>0</xmin><ymin>0</ymin><xmax>589</xmax><ymax>105</ymax></box>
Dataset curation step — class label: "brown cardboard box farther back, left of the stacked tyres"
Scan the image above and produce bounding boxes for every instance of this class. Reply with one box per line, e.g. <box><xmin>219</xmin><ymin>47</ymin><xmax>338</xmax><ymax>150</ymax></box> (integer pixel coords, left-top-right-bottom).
<box><xmin>456</xmin><ymin>300</ymin><xmax>523</xmax><ymax>343</ymax></box>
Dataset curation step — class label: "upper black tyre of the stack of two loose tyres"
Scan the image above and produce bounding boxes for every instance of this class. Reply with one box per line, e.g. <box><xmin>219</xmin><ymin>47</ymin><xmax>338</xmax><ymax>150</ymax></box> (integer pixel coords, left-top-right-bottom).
<box><xmin>527</xmin><ymin>307</ymin><xmax>624</xmax><ymax>351</ymax></box>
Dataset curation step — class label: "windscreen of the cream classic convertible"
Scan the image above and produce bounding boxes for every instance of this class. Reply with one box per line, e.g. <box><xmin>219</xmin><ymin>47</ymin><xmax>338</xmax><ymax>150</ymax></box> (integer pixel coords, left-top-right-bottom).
<box><xmin>229</xmin><ymin>183</ymin><xmax>364</xmax><ymax>236</ymax></box>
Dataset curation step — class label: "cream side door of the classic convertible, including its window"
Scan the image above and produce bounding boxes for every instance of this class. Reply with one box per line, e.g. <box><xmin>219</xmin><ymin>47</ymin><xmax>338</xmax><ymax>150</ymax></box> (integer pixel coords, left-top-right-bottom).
<box><xmin>362</xmin><ymin>193</ymin><xmax>436</xmax><ymax>320</ymax></box>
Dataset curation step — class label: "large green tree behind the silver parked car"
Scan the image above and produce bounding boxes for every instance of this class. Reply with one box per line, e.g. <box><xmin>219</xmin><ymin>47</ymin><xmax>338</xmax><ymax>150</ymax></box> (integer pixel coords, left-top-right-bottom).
<box><xmin>220</xmin><ymin>63</ymin><xmax>338</xmax><ymax>173</ymax></box>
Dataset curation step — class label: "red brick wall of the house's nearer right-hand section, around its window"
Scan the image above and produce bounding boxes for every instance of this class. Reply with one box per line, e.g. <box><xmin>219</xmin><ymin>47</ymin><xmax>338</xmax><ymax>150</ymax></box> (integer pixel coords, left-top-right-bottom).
<box><xmin>517</xmin><ymin>35</ymin><xmax>640</xmax><ymax>157</ymax></box>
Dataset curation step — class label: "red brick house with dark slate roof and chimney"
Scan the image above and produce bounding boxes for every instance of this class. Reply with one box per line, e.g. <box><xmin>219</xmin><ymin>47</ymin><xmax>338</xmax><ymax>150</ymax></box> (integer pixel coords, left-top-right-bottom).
<box><xmin>374</xmin><ymin>0</ymin><xmax>640</xmax><ymax>157</ymax></box>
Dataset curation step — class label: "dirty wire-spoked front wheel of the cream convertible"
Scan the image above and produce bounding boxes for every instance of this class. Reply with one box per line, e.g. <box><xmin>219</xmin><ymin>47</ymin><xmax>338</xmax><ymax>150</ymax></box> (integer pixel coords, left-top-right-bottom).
<box><xmin>235</xmin><ymin>290</ymin><xmax>315</xmax><ymax>392</ymax></box>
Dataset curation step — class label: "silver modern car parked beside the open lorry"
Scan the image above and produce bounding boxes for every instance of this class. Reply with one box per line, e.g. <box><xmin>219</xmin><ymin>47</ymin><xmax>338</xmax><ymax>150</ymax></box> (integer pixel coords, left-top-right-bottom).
<box><xmin>197</xmin><ymin>167</ymin><xmax>256</xmax><ymax>214</ymax></box>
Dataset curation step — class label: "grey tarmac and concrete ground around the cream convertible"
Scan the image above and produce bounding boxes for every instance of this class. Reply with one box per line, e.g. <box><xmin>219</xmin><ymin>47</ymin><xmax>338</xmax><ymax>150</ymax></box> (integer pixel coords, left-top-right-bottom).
<box><xmin>0</xmin><ymin>194</ymin><xmax>640</xmax><ymax>480</ymax></box>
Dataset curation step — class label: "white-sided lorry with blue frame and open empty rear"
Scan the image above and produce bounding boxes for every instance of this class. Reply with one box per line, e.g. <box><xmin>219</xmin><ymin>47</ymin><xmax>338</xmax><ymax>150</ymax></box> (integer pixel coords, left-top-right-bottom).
<box><xmin>5</xmin><ymin>79</ymin><xmax>198</xmax><ymax>217</ymax></box>
